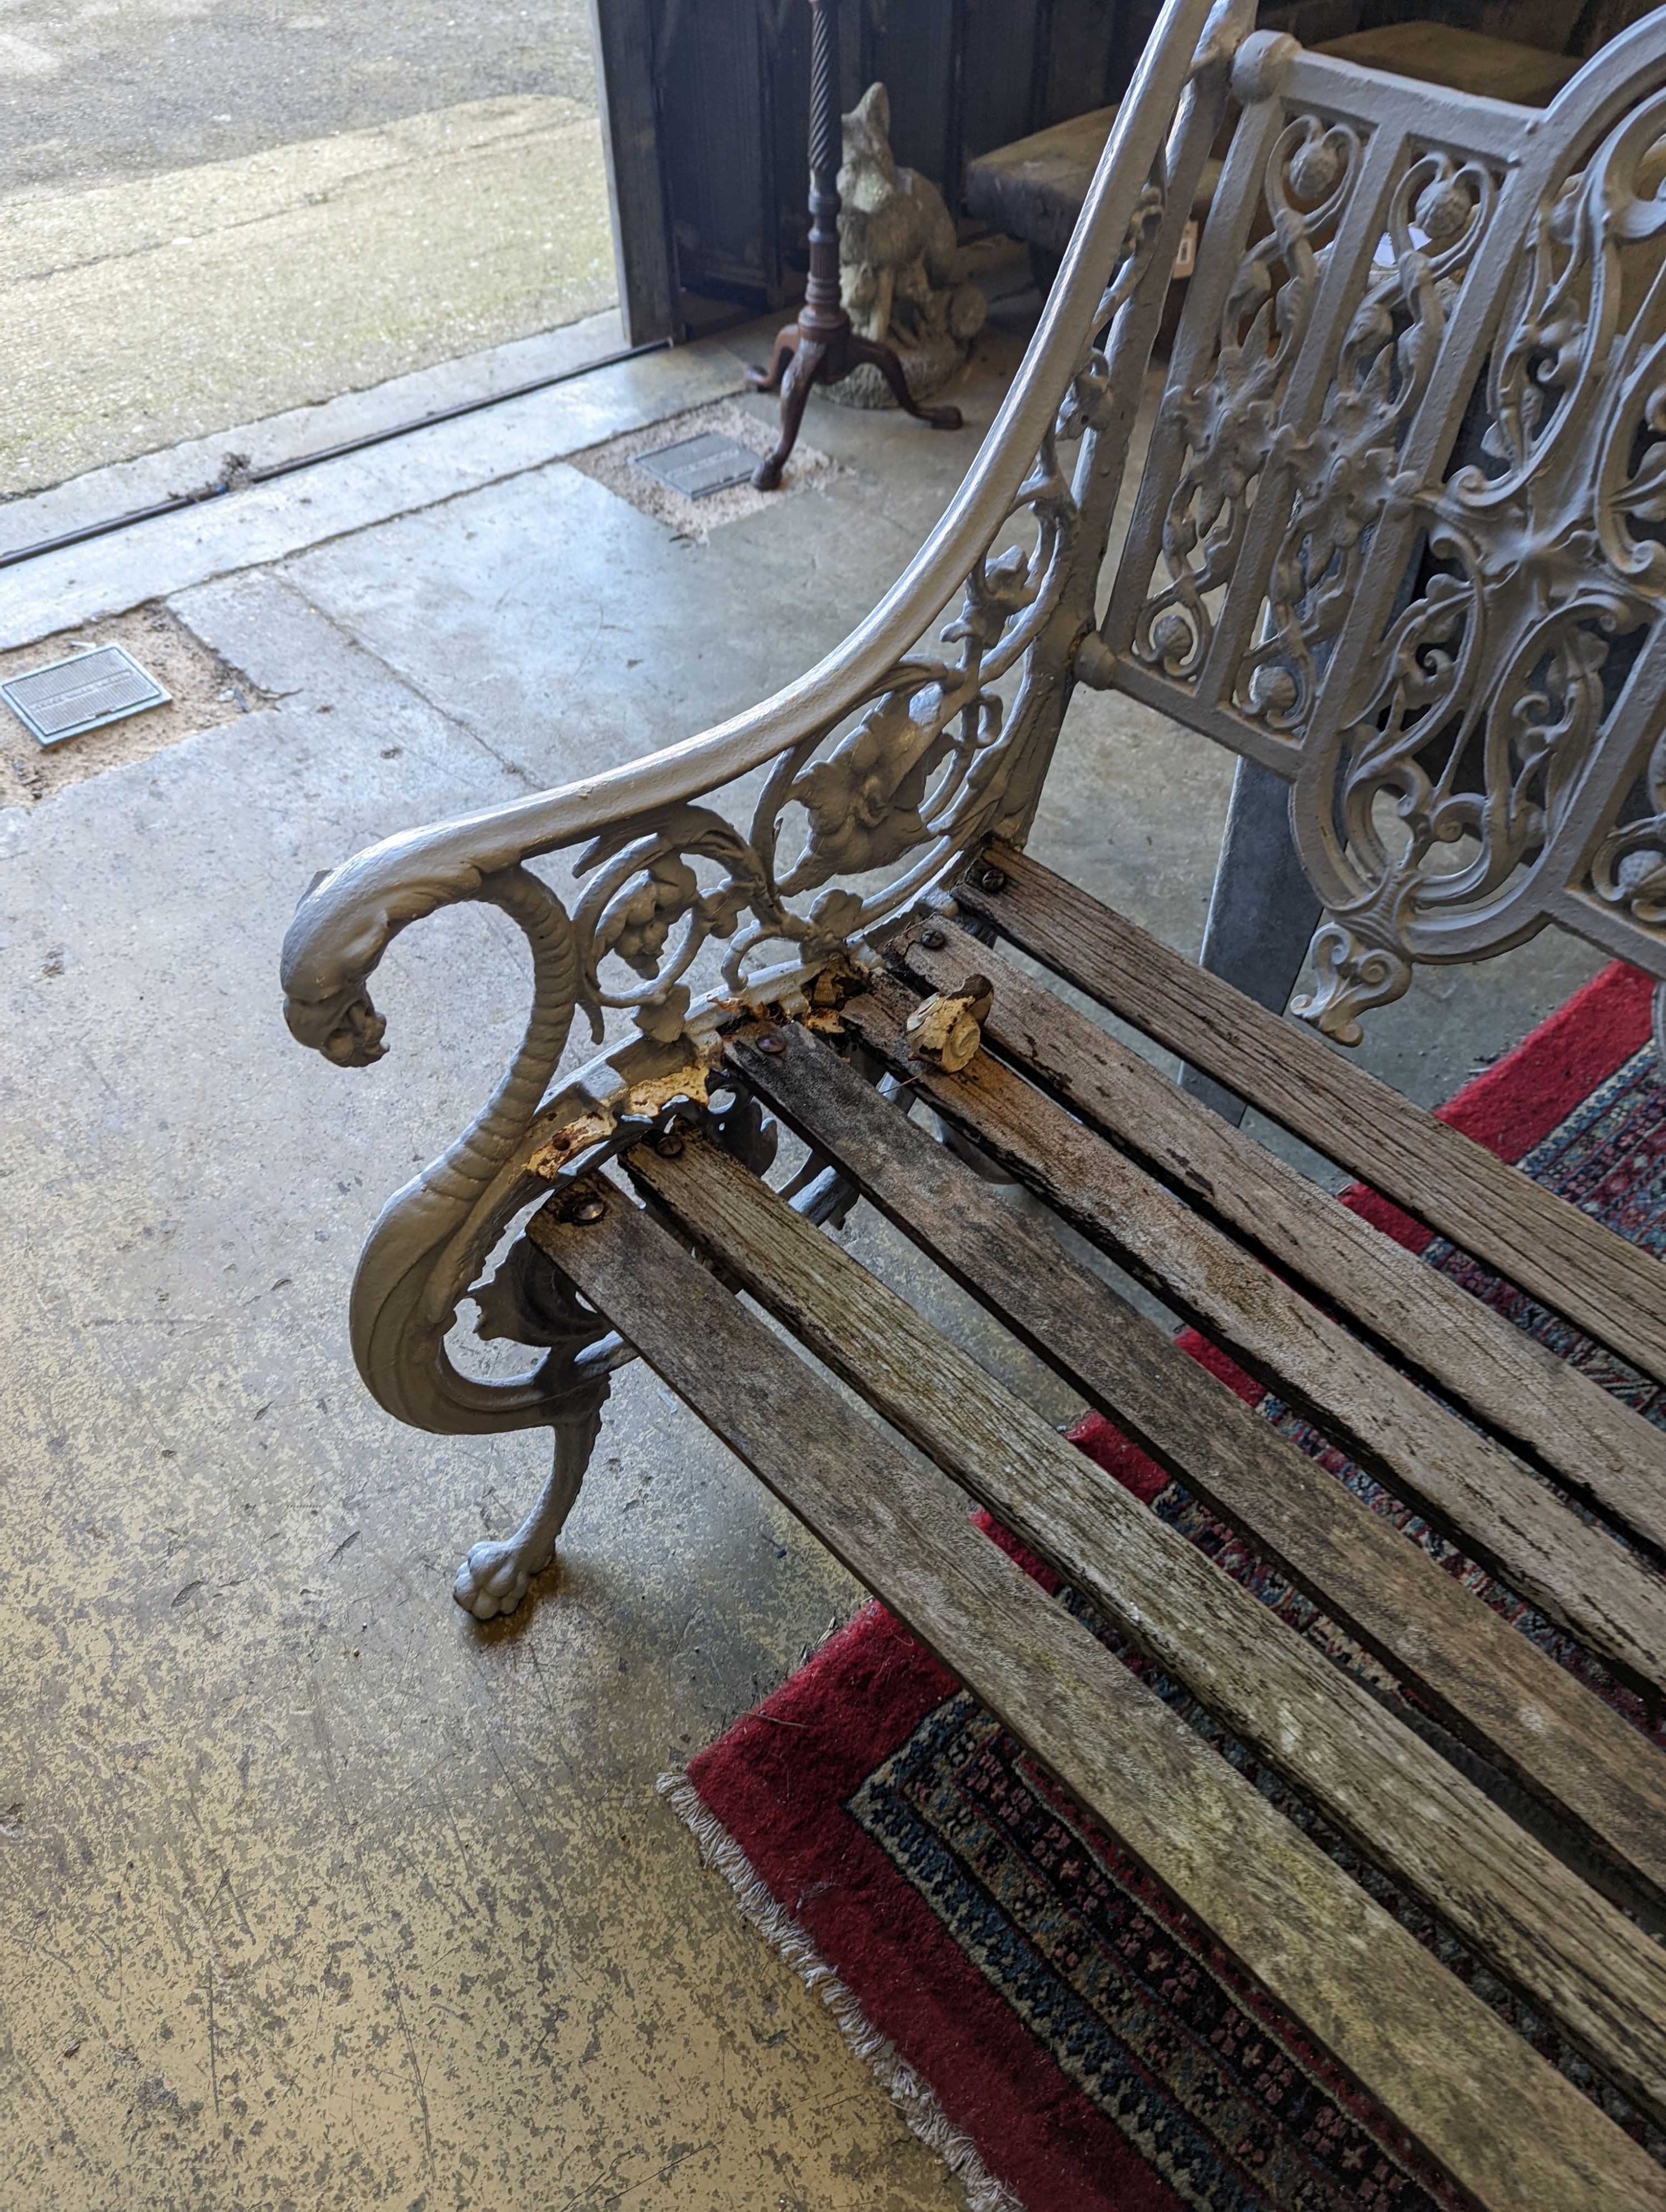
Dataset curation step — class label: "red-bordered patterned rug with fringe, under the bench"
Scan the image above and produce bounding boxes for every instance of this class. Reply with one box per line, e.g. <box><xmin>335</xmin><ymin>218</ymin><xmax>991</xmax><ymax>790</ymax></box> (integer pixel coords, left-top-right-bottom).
<box><xmin>661</xmin><ymin>967</ymin><xmax>1666</xmax><ymax>2212</ymax></box>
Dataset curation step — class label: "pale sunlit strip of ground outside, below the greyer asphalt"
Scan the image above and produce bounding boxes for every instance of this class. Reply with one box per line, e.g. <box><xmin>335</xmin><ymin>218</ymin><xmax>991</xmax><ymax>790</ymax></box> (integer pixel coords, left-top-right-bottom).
<box><xmin>0</xmin><ymin>94</ymin><xmax>615</xmax><ymax>497</ymax></box>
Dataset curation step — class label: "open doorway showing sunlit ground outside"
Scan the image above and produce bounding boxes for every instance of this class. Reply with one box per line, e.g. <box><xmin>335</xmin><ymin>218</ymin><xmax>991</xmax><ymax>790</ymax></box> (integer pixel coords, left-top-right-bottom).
<box><xmin>0</xmin><ymin>0</ymin><xmax>620</xmax><ymax>497</ymax></box>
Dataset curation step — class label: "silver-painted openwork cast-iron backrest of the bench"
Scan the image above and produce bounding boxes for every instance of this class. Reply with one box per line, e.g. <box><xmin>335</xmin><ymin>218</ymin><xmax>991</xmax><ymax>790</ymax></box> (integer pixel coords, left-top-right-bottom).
<box><xmin>1102</xmin><ymin>9</ymin><xmax>1666</xmax><ymax>1035</ymax></box>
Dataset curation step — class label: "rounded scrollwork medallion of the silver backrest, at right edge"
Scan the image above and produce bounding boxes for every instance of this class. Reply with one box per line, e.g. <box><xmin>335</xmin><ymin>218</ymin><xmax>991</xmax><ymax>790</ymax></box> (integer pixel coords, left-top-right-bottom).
<box><xmin>1303</xmin><ymin>99</ymin><xmax>1666</xmax><ymax>1035</ymax></box>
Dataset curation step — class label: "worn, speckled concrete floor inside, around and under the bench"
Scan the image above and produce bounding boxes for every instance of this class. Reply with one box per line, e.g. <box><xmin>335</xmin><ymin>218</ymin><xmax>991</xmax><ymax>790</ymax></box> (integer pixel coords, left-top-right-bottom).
<box><xmin>0</xmin><ymin>303</ymin><xmax>1597</xmax><ymax>2212</ymax></box>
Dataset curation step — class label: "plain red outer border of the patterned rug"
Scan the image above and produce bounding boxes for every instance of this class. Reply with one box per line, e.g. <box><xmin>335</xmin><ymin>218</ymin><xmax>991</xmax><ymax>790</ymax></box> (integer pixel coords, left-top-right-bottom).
<box><xmin>688</xmin><ymin>962</ymin><xmax>1653</xmax><ymax>2212</ymax></box>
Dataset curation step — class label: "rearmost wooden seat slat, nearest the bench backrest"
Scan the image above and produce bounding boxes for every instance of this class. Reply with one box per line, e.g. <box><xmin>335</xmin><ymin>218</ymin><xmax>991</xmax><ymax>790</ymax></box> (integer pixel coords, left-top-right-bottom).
<box><xmin>956</xmin><ymin>845</ymin><xmax>1666</xmax><ymax>1380</ymax></box>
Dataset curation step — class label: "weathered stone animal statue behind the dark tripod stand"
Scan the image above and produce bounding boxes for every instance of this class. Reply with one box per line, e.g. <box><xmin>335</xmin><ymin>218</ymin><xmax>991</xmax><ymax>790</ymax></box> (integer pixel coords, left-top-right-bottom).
<box><xmin>825</xmin><ymin>84</ymin><xmax>989</xmax><ymax>407</ymax></box>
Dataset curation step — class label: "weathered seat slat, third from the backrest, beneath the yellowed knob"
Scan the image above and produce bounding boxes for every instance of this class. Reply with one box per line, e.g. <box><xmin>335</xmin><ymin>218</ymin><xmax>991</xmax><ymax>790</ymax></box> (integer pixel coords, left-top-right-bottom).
<box><xmin>850</xmin><ymin>962</ymin><xmax>1666</xmax><ymax>1697</ymax></box>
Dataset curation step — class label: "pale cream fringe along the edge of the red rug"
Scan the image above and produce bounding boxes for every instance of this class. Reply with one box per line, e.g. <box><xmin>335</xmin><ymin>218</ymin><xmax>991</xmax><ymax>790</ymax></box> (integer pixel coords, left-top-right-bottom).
<box><xmin>657</xmin><ymin>1767</ymin><xmax>1025</xmax><ymax>2212</ymax></box>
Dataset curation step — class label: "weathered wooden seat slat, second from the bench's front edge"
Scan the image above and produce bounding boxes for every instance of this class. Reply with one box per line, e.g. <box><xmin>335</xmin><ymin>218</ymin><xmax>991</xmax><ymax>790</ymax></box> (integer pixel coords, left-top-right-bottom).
<box><xmin>633</xmin><ymin>1123</ymin><xmax>1666</xmax><ymax>2115</ymax></box>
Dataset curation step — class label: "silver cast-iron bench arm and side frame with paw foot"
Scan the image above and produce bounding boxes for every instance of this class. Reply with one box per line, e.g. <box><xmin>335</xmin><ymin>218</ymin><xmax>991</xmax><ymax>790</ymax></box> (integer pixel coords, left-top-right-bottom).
<box><xmin>283</xmin><ymin>0</ymin><xmax>1252</xmax><ymax>1617</ymax></box>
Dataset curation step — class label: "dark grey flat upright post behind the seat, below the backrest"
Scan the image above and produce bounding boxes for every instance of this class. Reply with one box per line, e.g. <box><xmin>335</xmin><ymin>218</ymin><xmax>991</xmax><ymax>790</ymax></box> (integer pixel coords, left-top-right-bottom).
<box><xmin>1180</xmin><ymin>761</ymin><xmax>1319</xmax><ymax>1128</ymax></box>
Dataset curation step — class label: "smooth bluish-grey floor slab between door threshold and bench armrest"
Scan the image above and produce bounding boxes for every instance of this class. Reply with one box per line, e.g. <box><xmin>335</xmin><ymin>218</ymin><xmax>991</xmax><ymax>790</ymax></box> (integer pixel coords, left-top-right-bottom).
<box><xmin>283</xmin><ymin>403</ymin><xmax>922</xmax><ymax>787</ymax></box>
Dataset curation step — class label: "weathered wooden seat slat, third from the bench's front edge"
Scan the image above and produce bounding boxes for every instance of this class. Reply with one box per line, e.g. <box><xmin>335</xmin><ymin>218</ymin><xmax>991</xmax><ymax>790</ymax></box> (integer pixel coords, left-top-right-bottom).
<box><xmin>730</xmin><ymin>1022</ymin><xmax>1666</xmax><ymax>1937</ymax></box>
